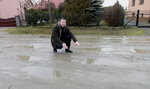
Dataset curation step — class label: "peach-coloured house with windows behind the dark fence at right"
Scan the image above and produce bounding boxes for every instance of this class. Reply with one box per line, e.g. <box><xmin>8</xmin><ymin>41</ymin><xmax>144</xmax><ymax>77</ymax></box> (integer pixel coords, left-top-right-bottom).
<box><xmin>128</xmin><ymin>0</ymin><xmax>150</xmax><ymax>17</ymax></box>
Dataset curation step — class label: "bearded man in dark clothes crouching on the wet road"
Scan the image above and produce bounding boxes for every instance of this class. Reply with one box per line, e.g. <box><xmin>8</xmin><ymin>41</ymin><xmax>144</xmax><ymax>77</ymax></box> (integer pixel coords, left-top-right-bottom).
<box><xmin>51</xmin><ymin>19</ymin><xmax>80</xmax><ymax>53</ymax></box>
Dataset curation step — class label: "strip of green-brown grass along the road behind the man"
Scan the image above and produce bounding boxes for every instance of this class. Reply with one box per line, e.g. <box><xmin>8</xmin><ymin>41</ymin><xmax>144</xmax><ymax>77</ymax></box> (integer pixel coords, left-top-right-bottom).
<box><xmin>5</xmin><ymin>27</ymin><xmax>146</xmax><ymax>36</ymax></box>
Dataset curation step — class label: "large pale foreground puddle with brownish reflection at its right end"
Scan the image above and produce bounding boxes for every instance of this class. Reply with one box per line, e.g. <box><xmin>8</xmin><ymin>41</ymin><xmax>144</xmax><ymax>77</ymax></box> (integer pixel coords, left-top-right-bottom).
<box><xmin>22</xmin><ymin>66</ymin><xmax>63</xmax><ymax>80</ymax></box>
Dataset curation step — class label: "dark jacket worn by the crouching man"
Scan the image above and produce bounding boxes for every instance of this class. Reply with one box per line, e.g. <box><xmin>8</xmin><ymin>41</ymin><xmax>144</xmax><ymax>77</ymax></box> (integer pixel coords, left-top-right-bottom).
<box><xmin>51</xmin><ymin>24</ymin><xmax>77</xmax><ymax>49</ymax></box>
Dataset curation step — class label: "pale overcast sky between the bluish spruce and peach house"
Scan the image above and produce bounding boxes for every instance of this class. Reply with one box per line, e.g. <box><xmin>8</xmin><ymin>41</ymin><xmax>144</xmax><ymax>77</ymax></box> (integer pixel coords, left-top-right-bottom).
<box><xmin>103</xmin><ymin>0</ymin><xmax>128</xmax><ymax>8</ymax></box>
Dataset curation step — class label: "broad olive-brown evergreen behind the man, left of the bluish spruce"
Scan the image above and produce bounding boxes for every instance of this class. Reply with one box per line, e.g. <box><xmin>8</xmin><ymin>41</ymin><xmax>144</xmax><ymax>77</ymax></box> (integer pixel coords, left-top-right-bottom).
<box><xmin>62</xmin><ymin>0</ymin><xmax>90</xmax><ymax>26</ymax></box>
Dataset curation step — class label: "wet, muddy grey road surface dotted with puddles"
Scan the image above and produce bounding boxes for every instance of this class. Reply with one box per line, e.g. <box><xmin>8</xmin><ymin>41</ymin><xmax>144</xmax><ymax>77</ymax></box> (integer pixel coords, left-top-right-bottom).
<box><xmin>0</xmin><ymin>32</ymin><xmax>150</xmax><ymax>89</ymax></box>
